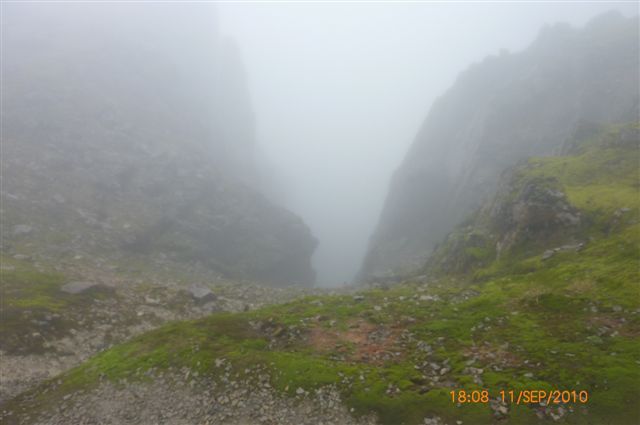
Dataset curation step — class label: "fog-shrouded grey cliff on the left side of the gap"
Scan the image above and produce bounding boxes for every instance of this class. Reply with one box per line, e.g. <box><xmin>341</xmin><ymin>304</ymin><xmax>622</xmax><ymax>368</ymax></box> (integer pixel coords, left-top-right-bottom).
<box><xmin>2</xmin><ymin>4</ymin><xmax>316</xmax><ymax>284</ymax></box>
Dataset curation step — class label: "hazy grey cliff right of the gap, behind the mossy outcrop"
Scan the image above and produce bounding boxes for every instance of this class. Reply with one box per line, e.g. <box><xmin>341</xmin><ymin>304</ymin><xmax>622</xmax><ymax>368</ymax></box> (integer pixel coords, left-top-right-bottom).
<box><xmin>359</xmin><ymin>13</ymin><xmax>640</xmax><ymax>281</ymax></box>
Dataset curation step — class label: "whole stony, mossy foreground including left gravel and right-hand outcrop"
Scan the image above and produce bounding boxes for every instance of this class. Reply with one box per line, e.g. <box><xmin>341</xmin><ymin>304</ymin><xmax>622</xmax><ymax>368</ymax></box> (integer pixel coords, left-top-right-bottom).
<box><xmin>0</xmin><ymin>127</ymin><xmax>640</xmax><ymax>425</ymax></box>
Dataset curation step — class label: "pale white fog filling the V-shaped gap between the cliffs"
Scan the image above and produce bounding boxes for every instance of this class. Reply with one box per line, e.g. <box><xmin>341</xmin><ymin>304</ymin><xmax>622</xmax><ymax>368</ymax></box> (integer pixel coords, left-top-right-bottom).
<box><xmin>218</xmin><ymin>2</ymin><xmax>637</xmax><ymax>286</ymax></box>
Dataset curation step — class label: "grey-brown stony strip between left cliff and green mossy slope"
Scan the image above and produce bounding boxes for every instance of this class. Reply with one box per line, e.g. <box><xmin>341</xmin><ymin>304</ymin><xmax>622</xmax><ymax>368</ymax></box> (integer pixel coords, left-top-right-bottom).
<box><xmin>0</xmin><ymin>276</ymin><xmax>350</xmax><ymax>406</ymax></box>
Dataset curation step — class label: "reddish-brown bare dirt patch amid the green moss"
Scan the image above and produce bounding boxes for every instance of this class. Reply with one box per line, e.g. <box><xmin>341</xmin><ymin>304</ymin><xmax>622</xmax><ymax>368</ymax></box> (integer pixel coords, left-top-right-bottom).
<box><xmin>309</xmin><ymin>320</ymin><xmax>401</xmax><ymax>364</ymax></box>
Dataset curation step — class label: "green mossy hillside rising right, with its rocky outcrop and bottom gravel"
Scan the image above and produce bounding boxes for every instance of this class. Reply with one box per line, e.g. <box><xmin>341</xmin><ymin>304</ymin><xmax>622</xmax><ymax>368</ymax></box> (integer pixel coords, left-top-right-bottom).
<box><xmin>0</xmin><ymin>124</ymin><xmax>640</xmax><ymax>425</ymax></box>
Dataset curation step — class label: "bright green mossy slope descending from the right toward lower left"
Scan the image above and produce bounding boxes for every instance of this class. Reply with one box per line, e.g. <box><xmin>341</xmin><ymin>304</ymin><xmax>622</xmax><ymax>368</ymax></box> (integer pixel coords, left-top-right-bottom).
<box><xmin>6</xmin><ymin>126</ymin><xmax>640</xmax><ymax>424</ymax></box>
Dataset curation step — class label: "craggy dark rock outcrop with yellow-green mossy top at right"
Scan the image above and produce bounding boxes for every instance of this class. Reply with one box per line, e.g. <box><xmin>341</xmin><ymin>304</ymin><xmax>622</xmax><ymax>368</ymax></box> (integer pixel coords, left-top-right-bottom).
<box><xmin>422</xmin><ymin>124</ymin><xmax>640</xmax><ymax>276</ymax></box>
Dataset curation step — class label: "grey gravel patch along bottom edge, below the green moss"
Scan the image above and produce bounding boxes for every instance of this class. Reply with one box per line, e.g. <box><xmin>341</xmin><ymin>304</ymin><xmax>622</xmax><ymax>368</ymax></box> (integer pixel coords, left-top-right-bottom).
<box><xmin>3</xmin><ymin>365</ymin><xmax>376</xmax><ymax>425</ymax></box>
